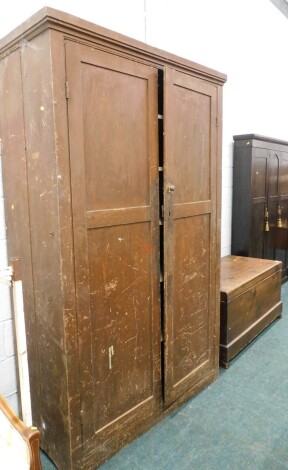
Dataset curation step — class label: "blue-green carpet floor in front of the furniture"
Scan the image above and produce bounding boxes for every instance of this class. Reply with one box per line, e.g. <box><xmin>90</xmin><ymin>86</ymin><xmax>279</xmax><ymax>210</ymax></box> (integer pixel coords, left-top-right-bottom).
<box><xmin>41</xmin><ymin>283</ymin><xmax>288</xmax><ymax>470</ymax></box>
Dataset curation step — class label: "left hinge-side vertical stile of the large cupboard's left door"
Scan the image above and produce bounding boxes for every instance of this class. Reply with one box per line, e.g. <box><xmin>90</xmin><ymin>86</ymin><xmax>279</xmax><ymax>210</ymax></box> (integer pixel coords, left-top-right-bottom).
<box><xmin>65</xmin><ymin>42</ymin><xmax>93</xmax><ymax>439</ymax></box>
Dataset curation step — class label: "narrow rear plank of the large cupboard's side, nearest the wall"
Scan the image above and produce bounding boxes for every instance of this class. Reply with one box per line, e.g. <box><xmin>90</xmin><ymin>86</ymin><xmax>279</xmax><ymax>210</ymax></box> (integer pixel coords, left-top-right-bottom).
<box><xmin>0</xmin><ymin>50</ymin><xmax>40</xmax><ymax>422</ymax></box>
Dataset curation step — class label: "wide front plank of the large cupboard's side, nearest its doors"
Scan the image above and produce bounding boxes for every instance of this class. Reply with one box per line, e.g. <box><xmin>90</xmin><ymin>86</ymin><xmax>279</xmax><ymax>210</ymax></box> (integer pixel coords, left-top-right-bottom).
<box><xmin>21</xmin><ymin>31</ymin><xmax>70</xmax><ymax>468</ymax></box>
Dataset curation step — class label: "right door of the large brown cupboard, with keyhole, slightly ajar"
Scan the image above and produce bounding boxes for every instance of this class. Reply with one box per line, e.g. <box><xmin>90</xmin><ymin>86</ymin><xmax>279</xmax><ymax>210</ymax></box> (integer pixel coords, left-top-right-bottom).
<box><xmin>164</xmin><ymin>69</ymin><xmax>219</xmax><ymax>403</ymax></box>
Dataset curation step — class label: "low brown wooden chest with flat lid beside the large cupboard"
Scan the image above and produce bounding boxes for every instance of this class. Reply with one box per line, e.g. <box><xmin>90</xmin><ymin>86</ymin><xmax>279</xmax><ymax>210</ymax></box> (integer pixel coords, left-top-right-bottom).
<box><xmin>220</xmin><ymin>255</ymin><xmax>282</xmax><ymax>367</ymax></box>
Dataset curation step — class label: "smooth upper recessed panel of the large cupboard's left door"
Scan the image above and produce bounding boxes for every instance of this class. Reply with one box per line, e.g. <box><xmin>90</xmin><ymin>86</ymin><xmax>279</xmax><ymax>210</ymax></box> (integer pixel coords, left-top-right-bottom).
<box><xmin>81</xmin><ymin>63</ymin><xmax>150</xmax><ymax>210</ymax></box>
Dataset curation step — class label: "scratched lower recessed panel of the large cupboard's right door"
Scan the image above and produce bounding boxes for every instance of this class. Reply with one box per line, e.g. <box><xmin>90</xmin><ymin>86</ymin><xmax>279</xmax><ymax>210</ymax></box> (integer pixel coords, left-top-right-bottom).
<box><xmin>168</xmin><ymin>214</ymin><xmax>210</xmax><ymax>384</ymax></box>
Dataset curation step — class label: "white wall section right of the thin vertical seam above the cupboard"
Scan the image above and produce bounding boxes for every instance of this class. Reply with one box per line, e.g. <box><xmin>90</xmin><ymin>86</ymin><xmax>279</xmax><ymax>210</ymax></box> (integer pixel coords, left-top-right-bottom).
<box><xmin>146</xmin><ymin>0</ymin><xmax>288</xmax><ymax>256</ymax></box>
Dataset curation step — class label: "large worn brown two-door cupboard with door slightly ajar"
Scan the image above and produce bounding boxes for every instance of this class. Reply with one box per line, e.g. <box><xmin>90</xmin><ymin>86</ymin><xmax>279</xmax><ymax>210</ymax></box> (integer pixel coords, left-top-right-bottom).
<box><xmin>0</xmin><ymin>8</ymin><xmax>225</xmax><ymax>470</ymax></box>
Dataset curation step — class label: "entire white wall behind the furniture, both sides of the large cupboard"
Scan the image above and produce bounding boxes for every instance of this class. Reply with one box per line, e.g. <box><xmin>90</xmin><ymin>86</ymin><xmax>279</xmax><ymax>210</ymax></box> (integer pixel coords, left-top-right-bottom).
<box><xmin>0</xmin><ymin>0</ymin><xmax>288</xmax><ymax>412</ymax></box>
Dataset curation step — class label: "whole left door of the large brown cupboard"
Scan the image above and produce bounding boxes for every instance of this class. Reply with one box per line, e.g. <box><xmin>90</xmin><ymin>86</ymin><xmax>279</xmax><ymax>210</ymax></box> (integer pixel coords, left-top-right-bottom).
<box><xmin>66</xmin><ymin>42</ymin><xmax>161</xmax><ymax>452</ymax></box>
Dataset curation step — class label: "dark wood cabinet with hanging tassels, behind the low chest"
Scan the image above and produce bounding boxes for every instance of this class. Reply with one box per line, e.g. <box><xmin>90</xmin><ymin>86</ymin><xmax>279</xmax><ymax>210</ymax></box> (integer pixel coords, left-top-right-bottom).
<box><xmin>232</xmin><ymin>134</ymin><xmax>288</xmax><ymax>281</ymax></box>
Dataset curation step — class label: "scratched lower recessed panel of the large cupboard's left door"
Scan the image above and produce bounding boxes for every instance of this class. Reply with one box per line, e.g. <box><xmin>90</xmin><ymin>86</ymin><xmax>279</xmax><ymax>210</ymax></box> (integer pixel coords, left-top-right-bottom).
<box><xmin>88</xmin><ymin>222</ymin><xmax>154</xmax><ymax>429</ymax></box>
